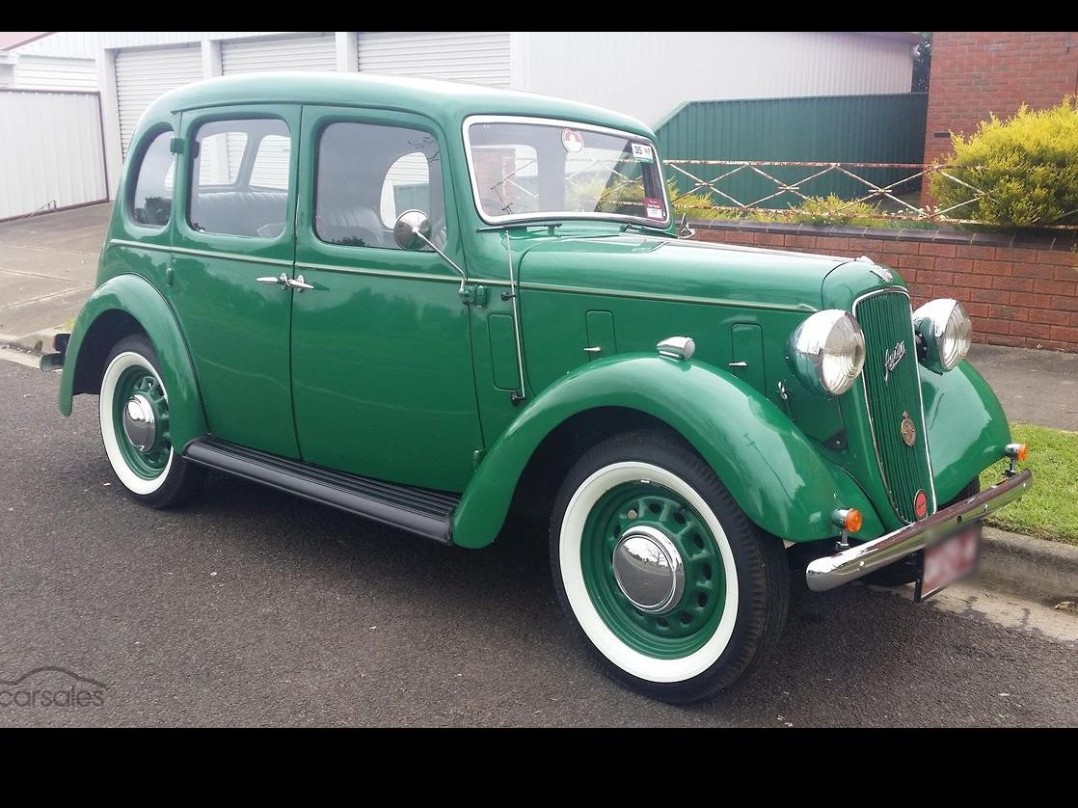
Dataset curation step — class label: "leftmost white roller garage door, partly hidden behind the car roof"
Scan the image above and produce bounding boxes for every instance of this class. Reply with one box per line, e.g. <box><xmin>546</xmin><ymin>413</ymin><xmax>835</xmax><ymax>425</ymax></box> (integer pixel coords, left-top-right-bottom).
<box><xmin>116</xmin><ymin>46</ymin><xmax>203</xmax><ymax>158</ymax></box>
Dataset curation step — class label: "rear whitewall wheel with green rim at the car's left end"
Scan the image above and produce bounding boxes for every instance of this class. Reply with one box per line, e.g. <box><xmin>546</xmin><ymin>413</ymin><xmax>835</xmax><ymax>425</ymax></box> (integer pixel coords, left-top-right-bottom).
<box><xmin>98</xmin><ymin>334</ymin><xmax>206</xmax><ymax>509</ymax></box>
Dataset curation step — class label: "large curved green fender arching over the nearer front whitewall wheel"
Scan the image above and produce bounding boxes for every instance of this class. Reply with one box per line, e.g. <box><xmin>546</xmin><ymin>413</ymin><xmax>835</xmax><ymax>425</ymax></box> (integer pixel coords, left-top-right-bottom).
<box><xmin>453</xmin><ymin>354</ymin><xmax>883</xmax><ymax>547</ymax></box>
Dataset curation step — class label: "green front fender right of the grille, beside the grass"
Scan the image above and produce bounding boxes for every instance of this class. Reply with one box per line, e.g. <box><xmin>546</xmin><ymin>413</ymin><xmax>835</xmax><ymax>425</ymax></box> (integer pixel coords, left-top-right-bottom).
<box><xmin>921</xmin><ymin>362</ymin><xmax>1011</xmax><ymax>502</ymax></box>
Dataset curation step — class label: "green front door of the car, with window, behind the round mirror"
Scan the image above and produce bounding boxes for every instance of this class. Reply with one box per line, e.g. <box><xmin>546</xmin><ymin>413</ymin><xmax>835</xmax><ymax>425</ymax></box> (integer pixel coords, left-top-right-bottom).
<box><xmin>292</xmin><ymin>107</ymin><xmax>483</xmax><ymax>491</ymax></box>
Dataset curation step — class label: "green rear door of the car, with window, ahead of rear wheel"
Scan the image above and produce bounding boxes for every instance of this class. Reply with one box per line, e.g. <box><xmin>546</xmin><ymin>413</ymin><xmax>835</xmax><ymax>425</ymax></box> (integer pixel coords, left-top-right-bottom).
<box><xmin>170</xmin><ymin>106</ymin><xmax>300</xmax><ymax>458</ymax></box>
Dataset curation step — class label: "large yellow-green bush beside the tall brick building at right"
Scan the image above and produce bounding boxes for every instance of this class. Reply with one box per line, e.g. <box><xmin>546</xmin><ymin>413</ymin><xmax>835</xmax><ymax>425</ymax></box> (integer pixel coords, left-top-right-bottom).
<box><xmin>930</xmin><ymin>96</ymin><xmax>1078</xmax><ymax>227</ymax></box>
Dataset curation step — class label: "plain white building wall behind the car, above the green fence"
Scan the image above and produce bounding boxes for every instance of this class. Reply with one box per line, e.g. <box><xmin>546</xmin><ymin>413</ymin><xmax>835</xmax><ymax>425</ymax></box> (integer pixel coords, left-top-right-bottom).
<box><xmin>513</xmin><ymin>31</ymin><xmax>913</xmax><ymax>126</ymax></box>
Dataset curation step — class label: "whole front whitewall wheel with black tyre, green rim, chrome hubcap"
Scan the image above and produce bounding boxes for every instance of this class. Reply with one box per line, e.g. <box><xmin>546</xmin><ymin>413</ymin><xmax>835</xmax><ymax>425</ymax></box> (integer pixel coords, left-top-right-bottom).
<box><xmin>550</xmin><ymin>431</ymin><xmax>789</xmax><ymax>703</ymax></box>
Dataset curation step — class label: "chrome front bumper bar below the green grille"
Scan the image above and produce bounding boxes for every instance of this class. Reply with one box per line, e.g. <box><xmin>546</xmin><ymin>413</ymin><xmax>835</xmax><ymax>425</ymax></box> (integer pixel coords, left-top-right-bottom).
<box><xmin>805</xmin><ymin>469</ymin><xmax>1033</xmax><ymax>591</ymax></box>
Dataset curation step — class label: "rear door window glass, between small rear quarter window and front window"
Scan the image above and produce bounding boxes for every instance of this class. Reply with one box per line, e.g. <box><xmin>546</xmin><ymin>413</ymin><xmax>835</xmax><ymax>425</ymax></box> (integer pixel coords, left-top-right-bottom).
<box><xmin>188</xmin><ymin>119</ymin><xmax>292</xmax><ymax>238</ymax></box>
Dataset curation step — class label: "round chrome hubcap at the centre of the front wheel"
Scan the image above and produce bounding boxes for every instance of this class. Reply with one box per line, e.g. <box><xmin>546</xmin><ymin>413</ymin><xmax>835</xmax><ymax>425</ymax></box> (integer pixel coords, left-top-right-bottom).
<box><xmin>611</xmin><ymin>525</ymin><xmax>685</xmax><ymax>614</ymax></box>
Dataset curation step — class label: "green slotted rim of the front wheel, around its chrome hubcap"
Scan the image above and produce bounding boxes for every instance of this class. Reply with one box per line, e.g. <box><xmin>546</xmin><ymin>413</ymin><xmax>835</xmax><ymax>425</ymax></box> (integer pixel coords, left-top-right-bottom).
<box><xmin>580</xmin><ymin>482</ymin><xmax>727</xmax><ymax>659</ymax></box>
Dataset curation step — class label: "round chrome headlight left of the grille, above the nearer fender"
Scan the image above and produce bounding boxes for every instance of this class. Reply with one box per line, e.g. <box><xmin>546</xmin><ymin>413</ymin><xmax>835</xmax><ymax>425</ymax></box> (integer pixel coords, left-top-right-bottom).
<box><xmin>788</xmin><ymin>309</ymin><xmax>865</xmax><ymax>395</ymax></box>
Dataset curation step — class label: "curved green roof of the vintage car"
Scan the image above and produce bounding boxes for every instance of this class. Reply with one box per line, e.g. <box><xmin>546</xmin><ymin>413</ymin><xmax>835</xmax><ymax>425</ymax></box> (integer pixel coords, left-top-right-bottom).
<box><xmin>143</xmin><ymin>71</ymin><xmax>653</xmax><ymax>137</ymax></box>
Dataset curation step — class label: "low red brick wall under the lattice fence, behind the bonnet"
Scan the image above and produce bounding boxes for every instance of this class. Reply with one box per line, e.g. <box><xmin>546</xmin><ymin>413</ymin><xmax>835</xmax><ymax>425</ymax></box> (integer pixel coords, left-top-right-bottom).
<box><xmin>696</xmin><ymin>228</ymin><xmax>1078</xmax><ymax>353</ymax></box>
